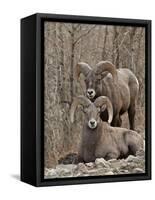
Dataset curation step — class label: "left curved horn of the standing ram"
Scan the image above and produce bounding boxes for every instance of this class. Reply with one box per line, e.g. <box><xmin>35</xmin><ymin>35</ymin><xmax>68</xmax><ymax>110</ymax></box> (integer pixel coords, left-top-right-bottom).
<box><xmin>76</xmin><ymin>62</ymin><xmax>92</xmax><ymax>78</ymax></box>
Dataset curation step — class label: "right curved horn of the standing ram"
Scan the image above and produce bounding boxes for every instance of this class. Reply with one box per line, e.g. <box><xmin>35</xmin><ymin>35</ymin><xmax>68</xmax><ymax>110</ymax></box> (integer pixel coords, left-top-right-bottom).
<box><xmin>95</xmin><ymin>61</ymin><xmax>117</xmax><ymax>81</ymax></box>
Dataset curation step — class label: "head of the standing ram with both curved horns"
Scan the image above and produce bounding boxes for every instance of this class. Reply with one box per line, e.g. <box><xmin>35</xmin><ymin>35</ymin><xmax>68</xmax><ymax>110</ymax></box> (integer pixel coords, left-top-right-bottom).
<box><xmin>76</xmin><ymin>61</ymin><xmax>117</xmax><ymax>101</ymax></box>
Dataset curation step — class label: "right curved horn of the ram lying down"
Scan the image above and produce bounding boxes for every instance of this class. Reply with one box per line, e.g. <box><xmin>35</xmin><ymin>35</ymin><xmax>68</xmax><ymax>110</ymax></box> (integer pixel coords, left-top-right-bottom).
<box><xmin>94</xmin><ymin>96</ymin><xmax>113</xmax><ymax>124</ymax></box>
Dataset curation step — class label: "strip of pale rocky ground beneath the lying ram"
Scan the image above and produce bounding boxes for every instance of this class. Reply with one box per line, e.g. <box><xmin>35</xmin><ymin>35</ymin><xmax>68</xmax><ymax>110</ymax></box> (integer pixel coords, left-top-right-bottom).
<box><xmin>45</xmin><ymin>150</ymin><xmax>145</xmax><ymax>178</ymax></box>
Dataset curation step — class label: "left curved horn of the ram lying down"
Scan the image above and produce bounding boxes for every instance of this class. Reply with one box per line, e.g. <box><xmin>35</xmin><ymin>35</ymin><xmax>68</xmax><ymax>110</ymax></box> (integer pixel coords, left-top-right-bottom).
<box><xmin>70</xmin><ymin>96</ymin><xmax>91</xmax><ymax>123</ymax></box>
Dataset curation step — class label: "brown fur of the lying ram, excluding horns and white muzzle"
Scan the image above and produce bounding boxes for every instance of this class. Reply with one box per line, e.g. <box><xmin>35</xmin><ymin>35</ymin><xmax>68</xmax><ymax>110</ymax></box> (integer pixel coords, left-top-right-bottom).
<box><xmin>71</xmin><ymin>97</ymin><xmax>143</xmax><ymax>162</ymax></box>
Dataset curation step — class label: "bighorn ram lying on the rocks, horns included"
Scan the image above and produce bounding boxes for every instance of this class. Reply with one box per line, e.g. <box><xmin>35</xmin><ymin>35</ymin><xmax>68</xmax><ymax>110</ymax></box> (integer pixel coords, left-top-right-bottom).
<box><xmin>71</xmin><ymin>96</ymin><xmax>143</xmax><ymax>162</ymax></box>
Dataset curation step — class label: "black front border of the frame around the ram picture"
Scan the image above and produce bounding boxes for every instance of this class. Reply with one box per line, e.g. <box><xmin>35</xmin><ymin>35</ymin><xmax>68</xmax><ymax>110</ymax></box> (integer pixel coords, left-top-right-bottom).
<box><xmin>23</xmin><ymin>14</ymin><xmax>151</xmax><ymax>186</ymax></box>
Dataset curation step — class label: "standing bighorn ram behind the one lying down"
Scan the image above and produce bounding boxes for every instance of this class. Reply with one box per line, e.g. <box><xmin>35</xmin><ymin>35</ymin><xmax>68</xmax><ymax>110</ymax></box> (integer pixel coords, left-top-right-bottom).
<box><xmin>76</xmin><ymin>61</ymin><xmax>139</xmax><ymax>130</ymax></box>
